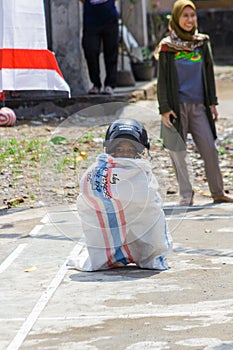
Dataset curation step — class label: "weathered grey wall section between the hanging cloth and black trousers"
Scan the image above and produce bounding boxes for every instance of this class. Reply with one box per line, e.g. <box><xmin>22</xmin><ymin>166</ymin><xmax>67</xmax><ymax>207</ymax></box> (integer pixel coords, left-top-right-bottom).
<box><xmin>50</xmin><ymin>0</ymin><xmax>89</xmax><ymax>97</ymax></box>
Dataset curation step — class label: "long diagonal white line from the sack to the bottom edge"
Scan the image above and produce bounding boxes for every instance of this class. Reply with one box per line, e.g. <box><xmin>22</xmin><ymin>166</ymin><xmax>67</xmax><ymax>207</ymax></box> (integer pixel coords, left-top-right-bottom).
<box><xmin>7</xmin><ymin>246</ymin><xmax>80</xmax><ymax>350</ymax></box>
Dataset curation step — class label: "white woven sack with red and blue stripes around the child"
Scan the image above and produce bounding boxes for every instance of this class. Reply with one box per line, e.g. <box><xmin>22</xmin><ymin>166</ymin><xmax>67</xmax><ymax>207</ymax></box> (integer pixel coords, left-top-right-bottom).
<box><xmin>67</xmin><ymin>154</ymin><xmax>172</xmax><ymax>271</ymax></box>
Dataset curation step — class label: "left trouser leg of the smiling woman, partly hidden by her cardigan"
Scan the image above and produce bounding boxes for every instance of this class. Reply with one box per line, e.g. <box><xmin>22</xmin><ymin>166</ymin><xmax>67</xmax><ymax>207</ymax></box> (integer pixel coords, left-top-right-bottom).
<box><xmin>169</xmin><ymin>103</ymin><xmax>193</xmax><ymax>205</ymax></box>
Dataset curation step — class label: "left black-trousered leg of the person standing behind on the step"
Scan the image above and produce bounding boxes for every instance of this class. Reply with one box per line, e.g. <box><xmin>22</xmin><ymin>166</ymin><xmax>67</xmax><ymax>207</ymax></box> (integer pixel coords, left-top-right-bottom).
<box><xmin>82</xmin><ymin>28</ymin><xmax>102</xmax><ymax>89</ymax></box>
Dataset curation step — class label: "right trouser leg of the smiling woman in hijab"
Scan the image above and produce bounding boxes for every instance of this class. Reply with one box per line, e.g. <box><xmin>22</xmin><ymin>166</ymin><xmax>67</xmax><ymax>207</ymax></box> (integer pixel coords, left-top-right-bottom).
<box><xmin>189</xmin><ymin>104</ymin><xmax>224</xmax><ymax>197</ymax></box>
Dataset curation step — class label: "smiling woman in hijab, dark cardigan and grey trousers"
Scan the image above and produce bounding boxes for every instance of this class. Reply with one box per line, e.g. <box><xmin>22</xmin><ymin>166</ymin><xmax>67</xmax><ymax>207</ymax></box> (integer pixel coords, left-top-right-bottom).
<box><xmin>155</xmin><ymin>0</ymin><xmax>233</xmax><ymax>206</ymax></box>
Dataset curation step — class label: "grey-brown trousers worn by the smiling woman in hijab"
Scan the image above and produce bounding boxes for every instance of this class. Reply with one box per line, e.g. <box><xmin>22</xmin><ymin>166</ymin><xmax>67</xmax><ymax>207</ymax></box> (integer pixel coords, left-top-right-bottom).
<box><xmin>169</xmin><ymin>103</ymin><xmax>224</xmax><ymax>199</ymax></box>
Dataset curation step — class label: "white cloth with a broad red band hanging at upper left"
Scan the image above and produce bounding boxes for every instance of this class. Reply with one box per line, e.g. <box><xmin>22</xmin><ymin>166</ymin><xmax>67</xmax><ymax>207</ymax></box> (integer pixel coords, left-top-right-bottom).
<box><xmin>0</xmin><ymin>0</ymin><xmax>70</xmax><ymax>95</ymax></box>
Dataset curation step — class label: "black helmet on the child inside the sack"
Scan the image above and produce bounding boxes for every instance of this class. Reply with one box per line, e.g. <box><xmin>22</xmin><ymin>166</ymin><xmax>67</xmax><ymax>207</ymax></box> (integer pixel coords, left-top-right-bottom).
<box><xmin>104</xmin><ymin>118</ymin><xmax>150</xmax><ymax>153</ymax></box>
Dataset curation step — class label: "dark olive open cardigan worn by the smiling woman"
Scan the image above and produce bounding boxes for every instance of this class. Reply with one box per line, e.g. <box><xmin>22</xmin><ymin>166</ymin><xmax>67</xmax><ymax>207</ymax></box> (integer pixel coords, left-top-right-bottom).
<box><xmin>157</xmin><ymin>41</ymin><xmax>218</xmax><ymax>151</ymax></box>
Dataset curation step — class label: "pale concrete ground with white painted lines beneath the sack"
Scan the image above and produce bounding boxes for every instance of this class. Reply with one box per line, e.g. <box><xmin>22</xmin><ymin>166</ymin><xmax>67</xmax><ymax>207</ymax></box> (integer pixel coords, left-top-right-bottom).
<box><xmin>0</xmin><ymin>77</ymin><xmax>233</xmax><ymax>350</ymax></box>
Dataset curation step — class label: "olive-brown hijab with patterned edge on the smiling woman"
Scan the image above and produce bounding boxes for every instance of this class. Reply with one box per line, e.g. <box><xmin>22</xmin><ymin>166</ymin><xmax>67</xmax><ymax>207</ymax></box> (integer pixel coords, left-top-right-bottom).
<box><xmin>155</xmin><ymin>0</ymin><xmax>209</xmax><ymax>59</ymax></box>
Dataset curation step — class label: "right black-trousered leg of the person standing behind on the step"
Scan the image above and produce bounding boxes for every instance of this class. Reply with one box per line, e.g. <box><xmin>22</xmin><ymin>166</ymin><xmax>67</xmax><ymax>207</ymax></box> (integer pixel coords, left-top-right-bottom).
<box><xmin>102</xmin><ymin>19</ymin><xmax>119</xmax><ymax>88</ymax></box>
